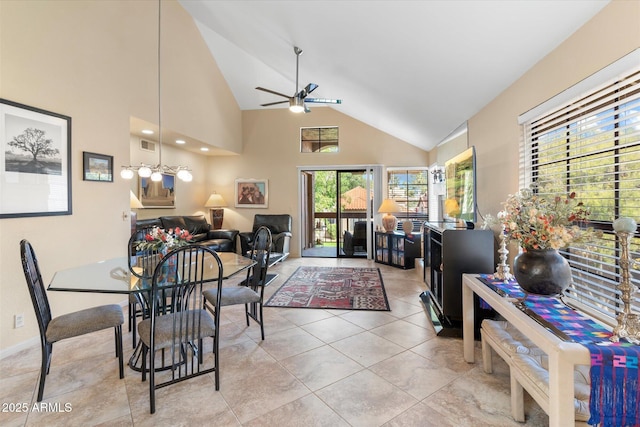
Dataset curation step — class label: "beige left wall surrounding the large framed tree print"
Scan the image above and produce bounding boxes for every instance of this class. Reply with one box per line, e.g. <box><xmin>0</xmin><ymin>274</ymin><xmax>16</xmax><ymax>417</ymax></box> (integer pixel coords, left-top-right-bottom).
<box><xmin>0</xmin><ymin>0</ymin><xmax>242</xmax><ymax>351</ymax></box>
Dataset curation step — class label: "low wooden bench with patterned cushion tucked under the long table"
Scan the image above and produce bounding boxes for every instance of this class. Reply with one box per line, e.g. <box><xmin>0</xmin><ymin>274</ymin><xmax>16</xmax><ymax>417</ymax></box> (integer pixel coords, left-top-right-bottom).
<box><xmin>480</xmin><ymin>319</ymin><xmax>590</xmax><ymax>426</ymax></box>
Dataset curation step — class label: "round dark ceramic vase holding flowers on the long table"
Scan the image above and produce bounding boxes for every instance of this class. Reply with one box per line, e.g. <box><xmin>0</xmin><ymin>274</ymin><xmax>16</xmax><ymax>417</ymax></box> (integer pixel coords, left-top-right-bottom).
<box><xmin>513</xmin><ymin>249</ymin><xmax>571</xmax><ymax>296</ymax></box>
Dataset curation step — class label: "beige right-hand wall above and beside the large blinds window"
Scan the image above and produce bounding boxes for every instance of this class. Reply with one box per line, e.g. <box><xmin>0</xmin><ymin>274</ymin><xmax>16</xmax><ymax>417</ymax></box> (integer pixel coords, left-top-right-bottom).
<box><xmin>468</xmin><ymin>0</ymin><xmax>640</xmax><ymax>221</ymax></box>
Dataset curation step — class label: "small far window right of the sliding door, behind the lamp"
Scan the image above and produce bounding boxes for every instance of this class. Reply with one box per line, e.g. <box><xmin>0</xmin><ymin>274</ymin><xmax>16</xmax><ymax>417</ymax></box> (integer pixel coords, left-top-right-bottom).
<box><xmin>387</xmin><ymin>168</ymin><xmax>429</xmax><ymax>230</ymax></box>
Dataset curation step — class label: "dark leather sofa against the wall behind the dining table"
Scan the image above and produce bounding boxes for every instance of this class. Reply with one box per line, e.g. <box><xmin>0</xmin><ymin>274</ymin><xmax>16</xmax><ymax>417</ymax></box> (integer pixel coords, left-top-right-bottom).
<box><xmin>136</xmin><ymin>215</ymin><xmax>239</xmax><ymax>252</ymax></box>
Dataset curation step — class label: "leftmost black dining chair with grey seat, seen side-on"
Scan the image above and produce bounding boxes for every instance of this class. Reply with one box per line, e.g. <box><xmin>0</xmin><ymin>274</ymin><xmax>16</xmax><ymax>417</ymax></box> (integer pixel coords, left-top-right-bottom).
<box><xmin>20</xmin><ymin>239</ymin><xmax>124</xmax><ymax>402</ymax></box>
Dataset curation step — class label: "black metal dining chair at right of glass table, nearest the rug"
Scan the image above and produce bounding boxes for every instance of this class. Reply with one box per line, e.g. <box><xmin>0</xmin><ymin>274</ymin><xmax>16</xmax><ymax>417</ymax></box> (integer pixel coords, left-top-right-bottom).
<box><xmin>204</xmin><ymin>226</ymin><xmax>271</xmax><ymax>341</ymax></box>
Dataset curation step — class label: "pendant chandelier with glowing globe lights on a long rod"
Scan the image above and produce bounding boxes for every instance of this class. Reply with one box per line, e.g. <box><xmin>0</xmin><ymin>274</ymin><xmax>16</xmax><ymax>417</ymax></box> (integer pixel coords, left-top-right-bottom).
<box><xmin>120</xmin><ymin>0</ymin><xmax>193</xmax><ymax>182</ymax></box>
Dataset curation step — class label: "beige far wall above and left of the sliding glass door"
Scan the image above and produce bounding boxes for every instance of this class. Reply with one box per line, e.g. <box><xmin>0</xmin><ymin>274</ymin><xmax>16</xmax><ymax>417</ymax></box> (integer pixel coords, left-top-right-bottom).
<box><xmin>208</xmin><ymin>107</ymin><xmax>428</xmax><ymax>256</ymax></box>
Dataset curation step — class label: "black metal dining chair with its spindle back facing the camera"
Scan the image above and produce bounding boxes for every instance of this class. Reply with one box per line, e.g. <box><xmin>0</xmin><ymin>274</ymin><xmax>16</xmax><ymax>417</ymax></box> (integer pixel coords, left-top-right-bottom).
<box><xmin>138</xmin><ymin>245</ymin><xmax>222</xmax><ymax>414</ymax></box>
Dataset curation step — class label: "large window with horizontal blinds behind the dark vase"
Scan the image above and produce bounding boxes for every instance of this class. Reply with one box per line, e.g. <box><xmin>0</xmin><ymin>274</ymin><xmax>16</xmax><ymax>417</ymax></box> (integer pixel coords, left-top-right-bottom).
<box><xmin>521</xmin><ymin>68</ymin><xmax>640</xmax><ymax>321</ymax></box>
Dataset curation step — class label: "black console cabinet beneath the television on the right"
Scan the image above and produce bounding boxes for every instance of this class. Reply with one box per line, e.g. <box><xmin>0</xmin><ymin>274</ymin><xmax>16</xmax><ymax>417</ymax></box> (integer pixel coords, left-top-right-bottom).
<box><xmin>420</xmin><ymin>222</ymin><xmax>496</xmax><ymax>336</ymax></box>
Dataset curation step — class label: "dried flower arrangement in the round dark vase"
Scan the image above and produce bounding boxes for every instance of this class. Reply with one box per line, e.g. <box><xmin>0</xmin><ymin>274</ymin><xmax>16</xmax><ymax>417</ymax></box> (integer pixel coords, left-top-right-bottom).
<box><xmin>498</xmin><ymin>189</ymin><xmax>594</xmax><ymax>250</ymax></box>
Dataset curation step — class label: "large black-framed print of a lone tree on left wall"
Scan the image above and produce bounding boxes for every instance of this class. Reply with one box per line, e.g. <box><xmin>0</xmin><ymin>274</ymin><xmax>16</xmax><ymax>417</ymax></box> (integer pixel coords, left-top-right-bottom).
<box><xmin>0</xmin><ymin>98</ymin><xmax>72</xmax><ymax>218</ymax></box>
